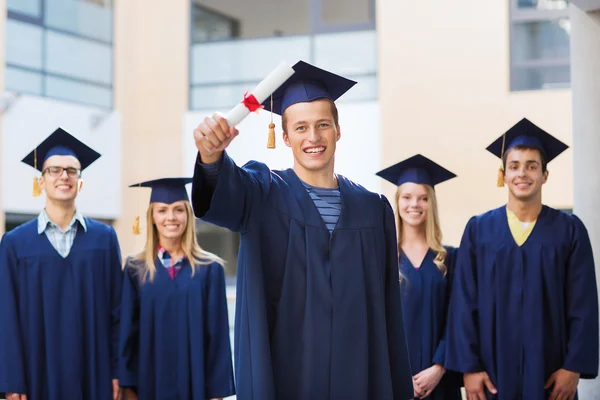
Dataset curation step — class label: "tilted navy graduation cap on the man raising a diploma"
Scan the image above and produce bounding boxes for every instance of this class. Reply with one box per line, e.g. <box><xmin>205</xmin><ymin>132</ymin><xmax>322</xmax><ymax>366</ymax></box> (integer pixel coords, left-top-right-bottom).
<box><xmin>262</xmin><ymin>61</ymin><xmax>356</xmax><ymax>148</ymax></box>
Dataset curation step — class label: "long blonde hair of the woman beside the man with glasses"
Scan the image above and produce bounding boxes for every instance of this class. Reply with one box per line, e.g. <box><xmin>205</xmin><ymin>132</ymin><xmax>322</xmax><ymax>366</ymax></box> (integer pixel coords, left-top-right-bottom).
<box><xmin>135</xmin><ymin>201</ymin><xmax>225</xmax><ymax>282</ymax></box>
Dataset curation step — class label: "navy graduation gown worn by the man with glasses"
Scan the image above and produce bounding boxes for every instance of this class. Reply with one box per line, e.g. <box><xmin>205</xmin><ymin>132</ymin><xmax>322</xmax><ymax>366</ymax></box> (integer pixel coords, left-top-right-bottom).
<box><xmin>0</xmin><ymin>218</ymin><xmax>122</xmax><ymax>400</ymax></box>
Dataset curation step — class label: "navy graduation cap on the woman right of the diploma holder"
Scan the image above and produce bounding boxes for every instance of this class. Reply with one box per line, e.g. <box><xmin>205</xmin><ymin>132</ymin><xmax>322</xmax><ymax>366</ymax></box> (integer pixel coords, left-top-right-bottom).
<box><xmin>377</xmin><ymin>154</ymin><xmax>456</xmax><ymax>187</ymax></box>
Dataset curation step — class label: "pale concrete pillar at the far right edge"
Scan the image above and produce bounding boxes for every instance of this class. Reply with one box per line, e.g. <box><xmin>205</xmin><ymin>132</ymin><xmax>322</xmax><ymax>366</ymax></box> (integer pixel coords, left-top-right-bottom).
<box><xmin>570</xmin><ymin>4</ymin><xmax>600</xmax><ymax>400</ymax></box>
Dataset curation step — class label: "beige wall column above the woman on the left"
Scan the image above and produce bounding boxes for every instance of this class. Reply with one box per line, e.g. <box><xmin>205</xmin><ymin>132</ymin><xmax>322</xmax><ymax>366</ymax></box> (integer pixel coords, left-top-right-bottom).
<box><xmin>114</xmin><ymin>0</ymin><xmax>190</xmax><ymax>256</ymax></box>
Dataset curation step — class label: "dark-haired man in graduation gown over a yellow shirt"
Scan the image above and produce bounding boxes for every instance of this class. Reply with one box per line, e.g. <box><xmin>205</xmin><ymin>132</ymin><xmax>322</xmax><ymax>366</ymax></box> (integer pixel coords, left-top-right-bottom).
<box><xmin>445</xmin><ymin>119</ymin><xmax>598</xmax><ymax>400</ymax></box>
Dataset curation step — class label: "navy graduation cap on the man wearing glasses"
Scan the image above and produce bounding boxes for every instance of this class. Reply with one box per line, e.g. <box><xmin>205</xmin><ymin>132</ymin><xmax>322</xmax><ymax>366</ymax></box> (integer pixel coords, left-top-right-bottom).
<box><xmin>21</xmin><ymin>128</ymin><xmax>100</xmax><ymax>196</ymax></box>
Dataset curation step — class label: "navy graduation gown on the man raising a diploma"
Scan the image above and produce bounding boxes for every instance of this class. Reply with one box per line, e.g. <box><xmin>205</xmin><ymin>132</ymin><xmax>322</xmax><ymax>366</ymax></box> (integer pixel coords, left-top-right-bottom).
<box><xmin>192</xmin><ymin>153</ymin><xmax>413</xmax><ymax>400</ymax></box>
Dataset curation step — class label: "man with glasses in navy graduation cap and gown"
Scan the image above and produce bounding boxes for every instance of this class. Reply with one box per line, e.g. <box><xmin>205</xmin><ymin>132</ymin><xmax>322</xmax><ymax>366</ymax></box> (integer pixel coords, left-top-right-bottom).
<box><xmin>0</xmin><ymin>128</ymin><xmax>122</xmax><ymax>400</ymax></box>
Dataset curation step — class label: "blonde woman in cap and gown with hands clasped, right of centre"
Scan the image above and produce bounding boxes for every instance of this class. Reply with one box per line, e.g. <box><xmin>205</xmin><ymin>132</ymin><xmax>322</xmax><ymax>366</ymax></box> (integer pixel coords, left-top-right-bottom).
<box><xmin>377</xmin><ymin>154</ymin><xmax>461</xmax><ymax>400</ymax></box>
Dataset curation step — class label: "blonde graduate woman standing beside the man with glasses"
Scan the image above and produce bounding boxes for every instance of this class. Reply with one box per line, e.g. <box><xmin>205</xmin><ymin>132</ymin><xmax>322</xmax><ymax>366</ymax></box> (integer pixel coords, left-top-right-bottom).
<box><xmin>118</xmin><ymin>178</ymin><xmax>235</xmax><ymax>400</ymax></box>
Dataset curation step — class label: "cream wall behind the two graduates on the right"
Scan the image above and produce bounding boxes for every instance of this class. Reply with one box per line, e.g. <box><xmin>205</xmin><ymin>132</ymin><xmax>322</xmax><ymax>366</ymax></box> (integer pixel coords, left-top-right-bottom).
<box><xmin>377</xmin><ymin>0</ymin><xmax>573</xmax><ymax>245</ymax></box>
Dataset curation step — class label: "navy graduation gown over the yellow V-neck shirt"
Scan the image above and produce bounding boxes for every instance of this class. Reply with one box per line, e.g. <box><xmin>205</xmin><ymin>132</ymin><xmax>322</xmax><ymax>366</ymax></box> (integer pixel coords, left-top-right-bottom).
<box><xmin>446</xmin><ymin>206</ymin><xmax>598</xmax><ymax>400</ymax></box>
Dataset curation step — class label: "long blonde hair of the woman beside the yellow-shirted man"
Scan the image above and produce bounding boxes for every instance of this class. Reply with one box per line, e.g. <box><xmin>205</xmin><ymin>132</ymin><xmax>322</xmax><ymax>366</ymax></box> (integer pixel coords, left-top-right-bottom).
<box><xmin>395</xmin><ymin>184</ymin><xmax>448</xmax><ymax>279</ymax></box>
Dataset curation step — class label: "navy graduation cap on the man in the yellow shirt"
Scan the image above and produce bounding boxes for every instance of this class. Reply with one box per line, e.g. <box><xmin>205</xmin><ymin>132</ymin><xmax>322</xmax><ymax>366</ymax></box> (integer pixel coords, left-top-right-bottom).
<box><xmin>487</xmin><ymin>118</ymin><xmax>569</xmax><ymax>187</ymax></box>
